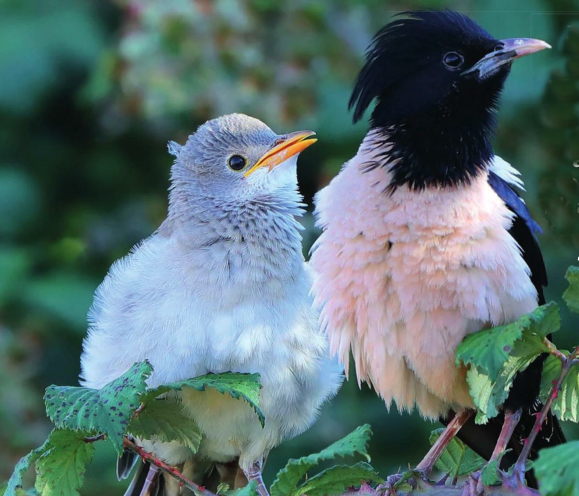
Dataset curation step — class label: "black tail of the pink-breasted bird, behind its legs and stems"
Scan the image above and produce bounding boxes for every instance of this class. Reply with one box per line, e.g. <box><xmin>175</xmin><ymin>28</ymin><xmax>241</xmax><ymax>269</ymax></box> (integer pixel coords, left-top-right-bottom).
<box><xmin>448</xmin><ymin>403</ymin><xmax>565</xmax><ymax>489</ymax></box>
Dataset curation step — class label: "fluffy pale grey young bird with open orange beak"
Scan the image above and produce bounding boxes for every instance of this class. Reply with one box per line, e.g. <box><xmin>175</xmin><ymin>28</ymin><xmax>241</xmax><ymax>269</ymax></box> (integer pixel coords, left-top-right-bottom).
<box><xmin>81</xmin><ymin>114</ymin><xmax>343</xmax><ymax>496</ymax></box>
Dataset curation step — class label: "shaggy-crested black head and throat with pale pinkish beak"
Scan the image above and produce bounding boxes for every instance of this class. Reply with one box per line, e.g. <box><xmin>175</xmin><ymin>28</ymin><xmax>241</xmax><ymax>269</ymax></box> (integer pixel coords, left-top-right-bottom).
<box><xmin>350</xmin><ymin>11</ymin><xmax>548</xmax><ymax>189</ymax></box>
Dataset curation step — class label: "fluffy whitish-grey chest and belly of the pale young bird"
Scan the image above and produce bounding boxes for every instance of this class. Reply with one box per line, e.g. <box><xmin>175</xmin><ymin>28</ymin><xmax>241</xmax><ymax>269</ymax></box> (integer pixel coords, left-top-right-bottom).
<box><xmin>82</xmin><ymin>231</ymin><xmax>341</xmax><ymax>468</ymax></box>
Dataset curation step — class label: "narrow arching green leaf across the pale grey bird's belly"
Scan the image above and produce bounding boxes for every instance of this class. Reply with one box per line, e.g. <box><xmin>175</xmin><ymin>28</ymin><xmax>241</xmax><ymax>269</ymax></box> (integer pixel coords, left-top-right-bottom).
<box><xmin>141</xmin><ymin>372</ymin><xmax>265</xmax><ymax>426</ymax></box>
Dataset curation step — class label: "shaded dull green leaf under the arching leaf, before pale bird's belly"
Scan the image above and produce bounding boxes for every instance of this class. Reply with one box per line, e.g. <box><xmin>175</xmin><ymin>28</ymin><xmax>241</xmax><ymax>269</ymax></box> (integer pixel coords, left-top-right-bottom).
<box><xmin>127</xmin><ymin>398</ymin><xmax>201</xmax><ymax>453</ymax></box>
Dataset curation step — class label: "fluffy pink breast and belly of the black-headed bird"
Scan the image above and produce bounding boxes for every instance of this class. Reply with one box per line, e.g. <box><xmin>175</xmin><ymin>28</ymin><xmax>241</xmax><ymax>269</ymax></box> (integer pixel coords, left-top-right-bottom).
<box><xmin>311</xmin><ymin>140</ymin><xmax>536</xmax><ymax>418</ymax></box>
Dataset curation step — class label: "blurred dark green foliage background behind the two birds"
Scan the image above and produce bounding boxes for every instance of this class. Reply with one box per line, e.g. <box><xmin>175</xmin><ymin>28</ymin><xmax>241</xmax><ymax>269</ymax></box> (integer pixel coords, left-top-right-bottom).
<box><xmin>0</xmin><ymin>0</ymin><xmax>579</xmax><ymax>495</ymax></box>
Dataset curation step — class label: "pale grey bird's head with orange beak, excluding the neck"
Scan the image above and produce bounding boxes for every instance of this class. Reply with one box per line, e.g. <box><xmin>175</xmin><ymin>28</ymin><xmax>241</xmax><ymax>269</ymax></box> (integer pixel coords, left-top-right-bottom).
<box><xmin>169</xmin><ymin>114</ymin><xmax>316</xmax><ymax>208</ymax></box>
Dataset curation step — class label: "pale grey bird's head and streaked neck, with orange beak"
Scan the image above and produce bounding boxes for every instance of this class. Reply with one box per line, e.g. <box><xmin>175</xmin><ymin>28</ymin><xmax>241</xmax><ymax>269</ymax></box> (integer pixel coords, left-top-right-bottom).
<box><xmin>160</xmin><ymin>114</ymin><xmax>316</xmax><ymax>257</ymax></box>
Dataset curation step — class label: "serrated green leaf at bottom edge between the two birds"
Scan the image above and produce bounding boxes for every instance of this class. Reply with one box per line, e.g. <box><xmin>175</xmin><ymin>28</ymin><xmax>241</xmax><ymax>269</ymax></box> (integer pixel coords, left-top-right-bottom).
<box><xmin>270</xmin><ymin>424</ymin><xmax>372</xmax><ymax>496</ymax></box>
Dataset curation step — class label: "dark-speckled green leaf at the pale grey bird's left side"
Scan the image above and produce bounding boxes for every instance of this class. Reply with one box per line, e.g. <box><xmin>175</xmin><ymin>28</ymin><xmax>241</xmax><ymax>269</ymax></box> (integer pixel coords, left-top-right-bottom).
<box><xmin>44</xmin><ymin>361</ymin><xmax>153</xmax><ymax>455</ymax></box>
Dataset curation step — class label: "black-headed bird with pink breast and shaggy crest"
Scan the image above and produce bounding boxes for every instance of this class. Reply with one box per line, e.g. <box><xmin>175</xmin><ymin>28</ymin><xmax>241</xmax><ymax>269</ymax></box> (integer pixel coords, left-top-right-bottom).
<box><xmin>310</xmin><ymin>10</ymin><xmax>564</xmax><ymax>485</ymax></box>
